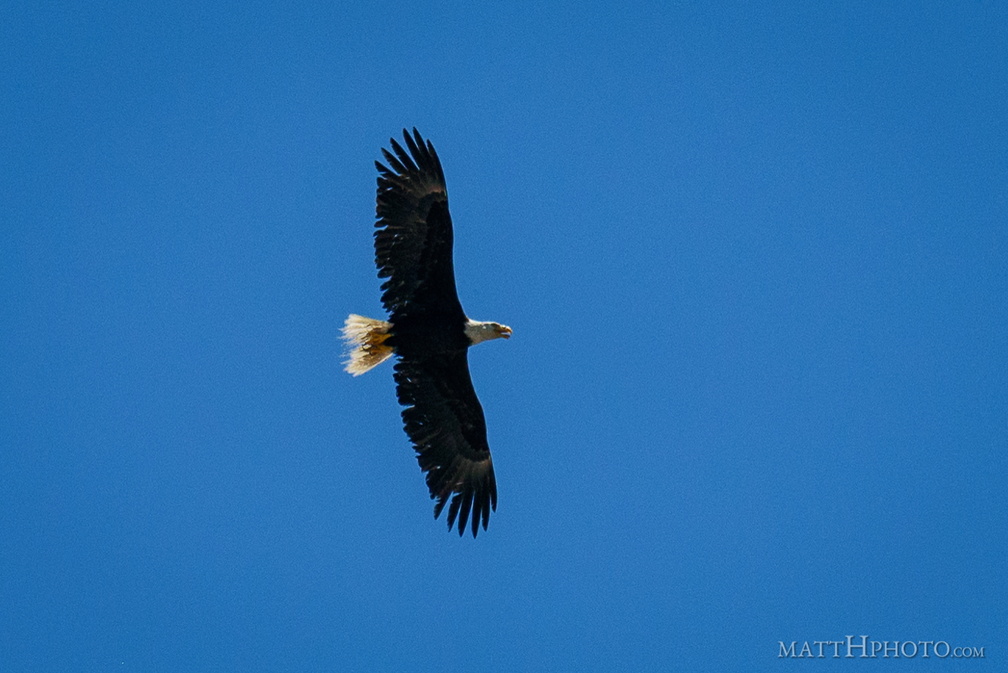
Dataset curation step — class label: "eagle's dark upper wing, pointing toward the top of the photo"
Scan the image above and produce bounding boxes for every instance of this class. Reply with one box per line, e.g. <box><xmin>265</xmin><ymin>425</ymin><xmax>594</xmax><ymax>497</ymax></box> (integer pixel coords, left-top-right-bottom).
<box><xmin>375</xmin><ymin>129</ymin><xmax>466</xmax><ymax>323</ymax></box>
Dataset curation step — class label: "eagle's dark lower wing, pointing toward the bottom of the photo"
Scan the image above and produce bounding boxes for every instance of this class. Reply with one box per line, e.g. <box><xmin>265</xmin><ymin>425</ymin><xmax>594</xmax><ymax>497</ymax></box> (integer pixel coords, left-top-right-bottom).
<box><xmin>395</xmin><ymin>350</ymin><xmax>497</xmax><ymax>537</ymax></box>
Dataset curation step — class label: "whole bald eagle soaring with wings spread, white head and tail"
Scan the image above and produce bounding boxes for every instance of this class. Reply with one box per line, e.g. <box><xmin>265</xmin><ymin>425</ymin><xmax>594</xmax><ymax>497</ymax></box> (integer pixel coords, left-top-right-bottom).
<box><xmin>343</xmin><ymin>128</ymin><xmax>511</xmax><ymax>538</ymax></box>
